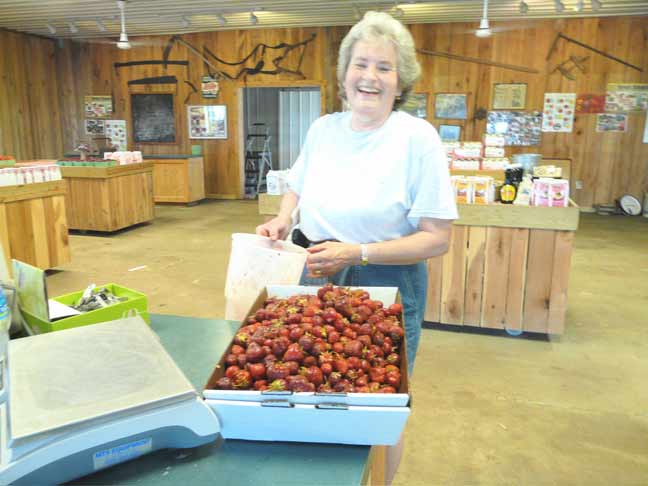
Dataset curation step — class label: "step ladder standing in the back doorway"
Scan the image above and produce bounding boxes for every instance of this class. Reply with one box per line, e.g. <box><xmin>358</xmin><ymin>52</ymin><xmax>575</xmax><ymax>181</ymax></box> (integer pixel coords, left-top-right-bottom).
<box><xmin>245</xmin><ymin>123</ymin><xmax>272</xmax><ymax>199</ymax></box>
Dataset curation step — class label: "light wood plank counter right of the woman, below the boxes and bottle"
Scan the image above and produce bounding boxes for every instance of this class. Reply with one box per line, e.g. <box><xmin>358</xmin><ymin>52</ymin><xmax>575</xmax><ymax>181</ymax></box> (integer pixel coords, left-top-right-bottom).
<box><xmin>425</xmin><ymin>204</ymin><xmax>579</xmax><ymax>334</ymax></box>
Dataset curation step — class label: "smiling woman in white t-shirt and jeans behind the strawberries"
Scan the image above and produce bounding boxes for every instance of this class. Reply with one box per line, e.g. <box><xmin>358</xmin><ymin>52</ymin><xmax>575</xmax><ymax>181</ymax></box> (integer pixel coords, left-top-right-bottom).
<box><xmin>257</xmin><ymin>12</ymin><xmax>457</xmax><ymax>371</ymax></box>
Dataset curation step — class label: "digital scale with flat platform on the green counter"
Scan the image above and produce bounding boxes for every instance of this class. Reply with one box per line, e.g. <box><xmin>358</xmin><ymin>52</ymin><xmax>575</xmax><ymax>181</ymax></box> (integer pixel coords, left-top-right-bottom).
<box><xmin>0</xmin><ymin>317</ymin><xmax>220</xmax><ymax>484</ymax></box>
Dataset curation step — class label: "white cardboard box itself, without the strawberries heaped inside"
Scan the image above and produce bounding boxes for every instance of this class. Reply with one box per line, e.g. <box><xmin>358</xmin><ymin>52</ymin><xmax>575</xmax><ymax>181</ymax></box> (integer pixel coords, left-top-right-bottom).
<box><xmin>203</xmin><ymin>285</ymin><xmax>411</xmax><ymax>445</ymax></box>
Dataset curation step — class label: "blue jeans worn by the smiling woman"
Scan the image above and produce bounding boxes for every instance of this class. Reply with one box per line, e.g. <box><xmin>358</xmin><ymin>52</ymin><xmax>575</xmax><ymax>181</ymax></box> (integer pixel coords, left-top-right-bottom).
<box><xmin>301</xmin><ymin>262</ymin><xmax>427</xmax><ymax>375</ymax></box>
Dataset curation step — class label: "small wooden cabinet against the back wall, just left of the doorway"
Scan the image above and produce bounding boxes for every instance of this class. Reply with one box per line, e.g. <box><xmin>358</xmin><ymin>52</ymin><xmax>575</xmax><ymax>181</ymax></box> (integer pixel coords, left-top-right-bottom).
<box><xmin>147</xmin><ymin>157</ymin><xmax>205</xmax><ymax>203</ymax></box>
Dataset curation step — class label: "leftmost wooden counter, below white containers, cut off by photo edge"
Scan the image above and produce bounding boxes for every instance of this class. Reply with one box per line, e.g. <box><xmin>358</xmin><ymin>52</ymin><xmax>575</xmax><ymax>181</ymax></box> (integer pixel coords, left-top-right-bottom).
<box><xmin>0</xmin><ymin>181</ymin><xmax>70</xmax><ymax>270</ymax></box>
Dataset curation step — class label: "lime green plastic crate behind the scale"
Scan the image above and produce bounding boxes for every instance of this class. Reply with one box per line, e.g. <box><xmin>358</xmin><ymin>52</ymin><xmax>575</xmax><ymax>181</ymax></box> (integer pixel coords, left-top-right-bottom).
<box><xmin>22</xmin><ymin>283</ymin><xmax>151</xmax><ymax>333</ymax></box>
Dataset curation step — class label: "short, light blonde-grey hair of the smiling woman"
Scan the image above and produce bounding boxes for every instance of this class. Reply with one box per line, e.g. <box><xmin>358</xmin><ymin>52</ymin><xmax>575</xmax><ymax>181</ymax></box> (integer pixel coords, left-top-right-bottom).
<box><xmin>337</xmin><ymin>12</ymin><xmax>421</xmax><ymax>109</ymax></box>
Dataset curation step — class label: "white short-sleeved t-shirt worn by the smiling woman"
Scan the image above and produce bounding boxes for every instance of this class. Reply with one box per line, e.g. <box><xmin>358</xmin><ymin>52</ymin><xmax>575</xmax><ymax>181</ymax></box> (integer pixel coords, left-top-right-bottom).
<box><xmin>288</xmin><ymin>111</ymin><xmax>457</xmax><ymax>243</ymax></box>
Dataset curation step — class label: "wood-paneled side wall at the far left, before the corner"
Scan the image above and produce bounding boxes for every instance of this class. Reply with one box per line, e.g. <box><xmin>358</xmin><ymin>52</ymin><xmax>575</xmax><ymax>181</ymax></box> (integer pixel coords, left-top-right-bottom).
<box><xmin>0</xmin><ymin>29</ymin><xmax>64</xmax><ymax>160</ymax></box>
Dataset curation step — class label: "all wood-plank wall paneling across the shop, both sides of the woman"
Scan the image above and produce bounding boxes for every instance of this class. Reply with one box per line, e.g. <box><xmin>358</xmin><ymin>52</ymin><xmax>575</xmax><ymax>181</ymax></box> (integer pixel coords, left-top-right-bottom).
<box><xmin>0</xmin><ymin>17</ymin><xmax>648</xmax><ymax>207</ymax></box>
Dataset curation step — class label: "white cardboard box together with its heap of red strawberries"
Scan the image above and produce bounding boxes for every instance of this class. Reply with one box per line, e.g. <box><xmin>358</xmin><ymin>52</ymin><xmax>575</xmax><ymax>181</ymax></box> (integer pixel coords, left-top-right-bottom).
<box><xmin>203</xmin><ymin>284</ymin><xmax>410</xmax><ymax>445</ymax></box>
